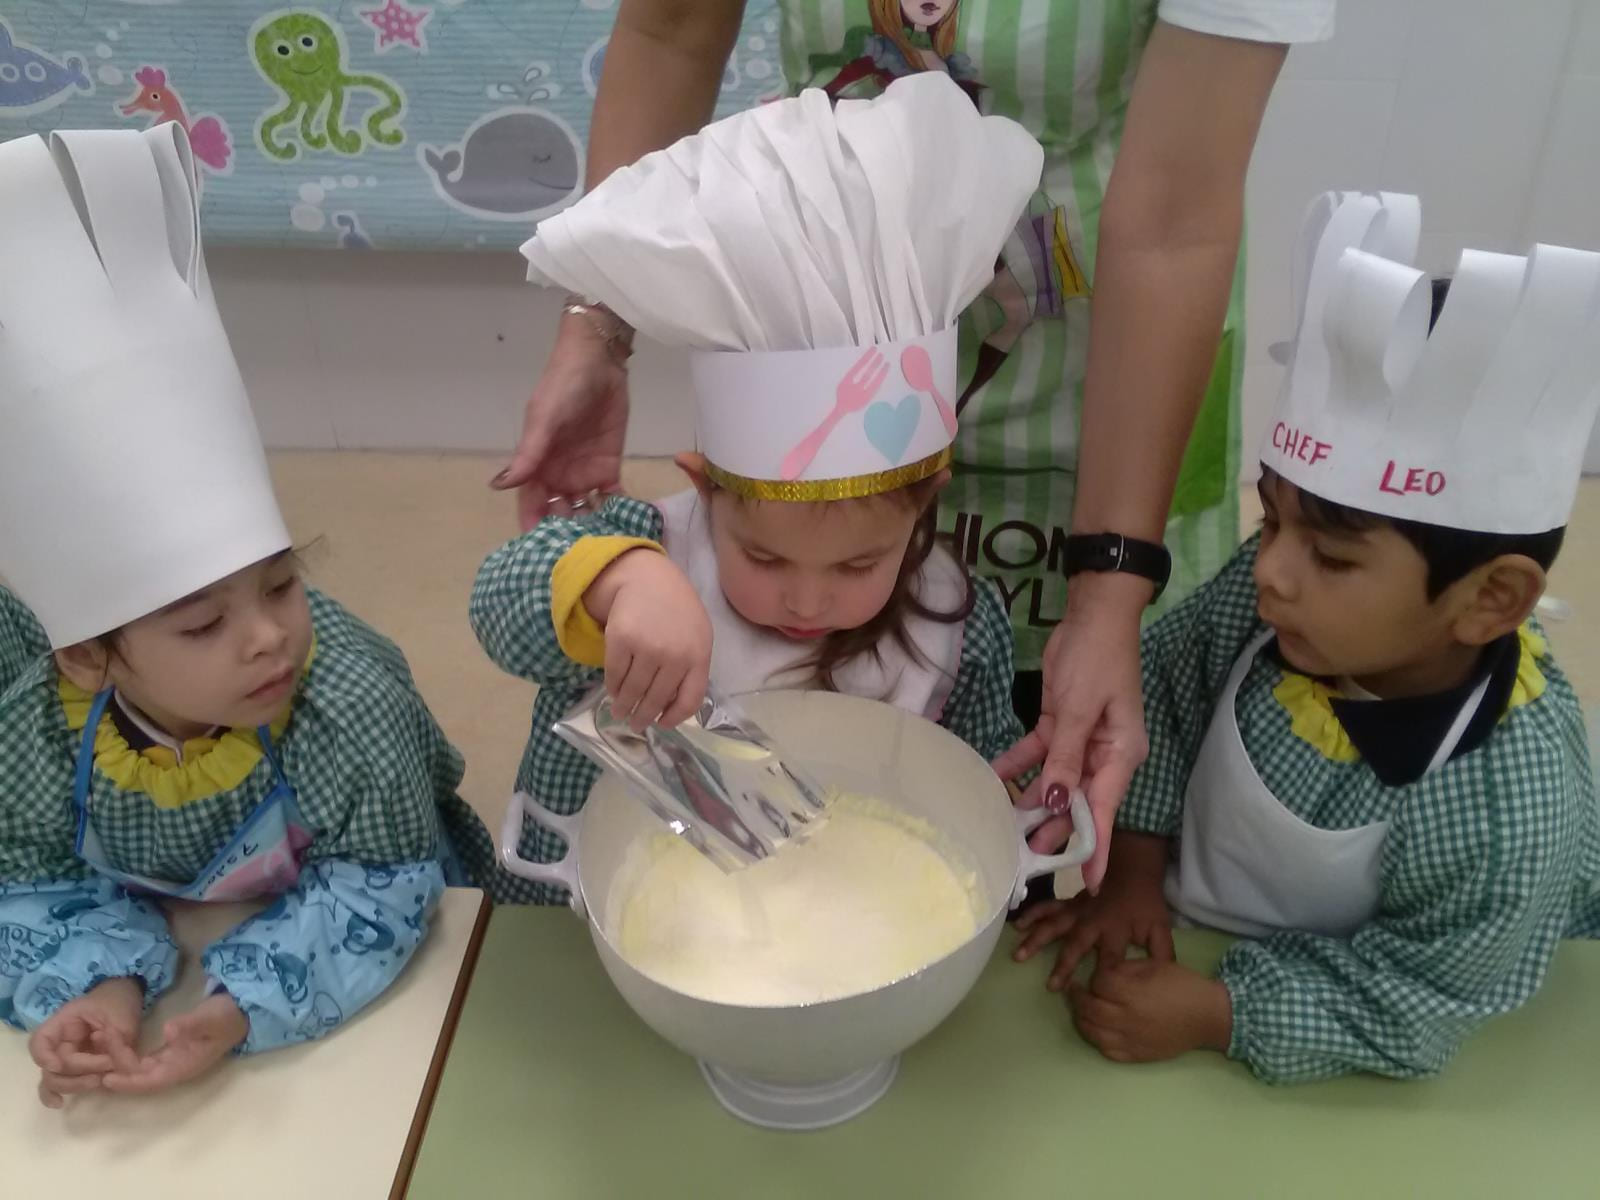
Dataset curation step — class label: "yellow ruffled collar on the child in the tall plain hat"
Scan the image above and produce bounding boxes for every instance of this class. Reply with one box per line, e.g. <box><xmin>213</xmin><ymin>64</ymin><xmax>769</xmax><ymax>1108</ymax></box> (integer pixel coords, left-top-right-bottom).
<box><xmin>56</xmin><ymin>638</ymin><xmax>317</xmax><ymax>808</ymax></box>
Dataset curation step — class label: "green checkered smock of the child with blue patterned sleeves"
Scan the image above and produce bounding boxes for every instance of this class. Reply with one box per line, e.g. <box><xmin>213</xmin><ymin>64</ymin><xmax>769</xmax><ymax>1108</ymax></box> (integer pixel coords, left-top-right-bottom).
<box><xmin>0</xmin><ymin>589</ymin><xmax>501</xmax><ymax>891</ymax></box>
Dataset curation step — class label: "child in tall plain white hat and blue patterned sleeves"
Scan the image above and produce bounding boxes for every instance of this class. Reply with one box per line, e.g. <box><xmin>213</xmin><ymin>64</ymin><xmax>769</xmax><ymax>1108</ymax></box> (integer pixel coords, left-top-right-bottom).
<box><xmin>0</xmin><ymin>125</ymin><xmax>508</xmax><ymax>1106</ymax></box>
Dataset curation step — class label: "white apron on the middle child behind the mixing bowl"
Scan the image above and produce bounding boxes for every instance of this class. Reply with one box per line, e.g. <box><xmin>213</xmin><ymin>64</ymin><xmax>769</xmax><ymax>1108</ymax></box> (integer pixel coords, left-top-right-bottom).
<box><xmin>658</xmin><ymin>491</ymin><xmax>963</xmax><ymax>720</ymax></box>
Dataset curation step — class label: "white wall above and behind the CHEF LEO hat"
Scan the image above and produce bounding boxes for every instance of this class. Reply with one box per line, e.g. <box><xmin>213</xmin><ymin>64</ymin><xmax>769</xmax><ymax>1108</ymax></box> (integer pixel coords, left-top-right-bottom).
<box><xmin>1245</xmin><ymin>0</ymin><xmax>1600</xmax><ymax>477</ymax></box>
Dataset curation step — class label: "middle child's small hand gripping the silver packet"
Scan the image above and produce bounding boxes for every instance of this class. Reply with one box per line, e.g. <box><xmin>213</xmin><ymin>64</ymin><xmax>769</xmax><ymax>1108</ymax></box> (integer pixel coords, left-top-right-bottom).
<box><xmin>584</xmin><ymin>549</ymin><xmax>710</xmax><ymax>733</ymax></box>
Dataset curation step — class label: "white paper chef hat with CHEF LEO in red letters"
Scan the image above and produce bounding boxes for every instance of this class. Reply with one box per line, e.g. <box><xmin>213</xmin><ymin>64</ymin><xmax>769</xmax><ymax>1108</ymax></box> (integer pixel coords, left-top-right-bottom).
<box><xmin>1261</xmin><ymin>192</ymin><xmax>1600</xmax><ymax>534</ymax></box>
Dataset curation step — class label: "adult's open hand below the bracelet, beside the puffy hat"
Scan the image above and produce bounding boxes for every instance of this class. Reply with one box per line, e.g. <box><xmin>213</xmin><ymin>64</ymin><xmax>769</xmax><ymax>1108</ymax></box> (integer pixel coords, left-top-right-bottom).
<box><xmin>490</xmin><ymin>314</ymin><xmax>627</xmax><ymax>530</ymax></box>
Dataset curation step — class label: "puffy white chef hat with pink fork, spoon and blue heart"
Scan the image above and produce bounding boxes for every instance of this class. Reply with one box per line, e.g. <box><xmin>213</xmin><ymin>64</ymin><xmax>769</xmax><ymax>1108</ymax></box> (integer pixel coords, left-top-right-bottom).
<box><xmin>522</xmin><ymin>72</ymin><xmax>1043</xmax><ymax>501</ymax></box>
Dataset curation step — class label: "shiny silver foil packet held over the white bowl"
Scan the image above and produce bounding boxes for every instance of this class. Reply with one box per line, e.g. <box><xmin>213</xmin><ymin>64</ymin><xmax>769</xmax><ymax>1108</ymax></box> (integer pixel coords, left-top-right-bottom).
<box><xmin>555</xmin><ymin>688</ymin><xmax>827</xmax><ymax>870</ymax></box>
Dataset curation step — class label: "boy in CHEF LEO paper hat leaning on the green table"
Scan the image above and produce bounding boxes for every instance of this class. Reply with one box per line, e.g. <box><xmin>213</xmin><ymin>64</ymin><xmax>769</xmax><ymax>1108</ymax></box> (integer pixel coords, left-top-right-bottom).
<box><xmin>1019</xmin><ymin>194</ymin><xmax>1600</xmax><ymax>1082</ymax></box>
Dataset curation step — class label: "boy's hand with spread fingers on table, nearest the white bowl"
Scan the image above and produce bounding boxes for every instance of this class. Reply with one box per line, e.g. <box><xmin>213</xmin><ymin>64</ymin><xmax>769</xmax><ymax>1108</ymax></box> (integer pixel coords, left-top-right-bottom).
<box><xmin>1013</xmin><ymin>834</ymin><xmax>1173</xmax><ymax>992</ymax></box>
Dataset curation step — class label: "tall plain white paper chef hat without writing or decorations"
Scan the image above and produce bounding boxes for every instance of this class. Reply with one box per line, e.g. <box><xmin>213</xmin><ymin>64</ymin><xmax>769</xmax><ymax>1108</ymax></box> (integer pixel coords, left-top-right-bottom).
<box><xmin>0</xmin><ymin>123</ymin><xmax>290</xmax><ymax>648</ymax></box>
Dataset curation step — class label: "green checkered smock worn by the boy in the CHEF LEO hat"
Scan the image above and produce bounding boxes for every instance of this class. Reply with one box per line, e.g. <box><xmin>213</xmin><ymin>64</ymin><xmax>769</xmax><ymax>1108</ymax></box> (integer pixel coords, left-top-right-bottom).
<box><xmin>1117</xmin><ymin>541</ymin><xmax>1600</xmax><ymax>1083</ymax></box>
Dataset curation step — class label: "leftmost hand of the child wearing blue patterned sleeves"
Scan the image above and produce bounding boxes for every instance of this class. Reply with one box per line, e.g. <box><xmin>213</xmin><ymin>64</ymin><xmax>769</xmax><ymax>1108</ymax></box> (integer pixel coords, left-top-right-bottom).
<box><xmin>27</xmin><ymin>979</ymin><xmax>144</xmax><ymax>1109</ymax></box>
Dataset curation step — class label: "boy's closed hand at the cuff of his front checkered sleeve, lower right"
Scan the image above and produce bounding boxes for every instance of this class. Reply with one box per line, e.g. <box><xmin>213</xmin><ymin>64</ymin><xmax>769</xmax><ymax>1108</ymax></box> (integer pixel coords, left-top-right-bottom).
<box><xmin>1067</xmin><ymin>958</ymin><xmax>1234</xmax><ymax>1062</ymax></box>
